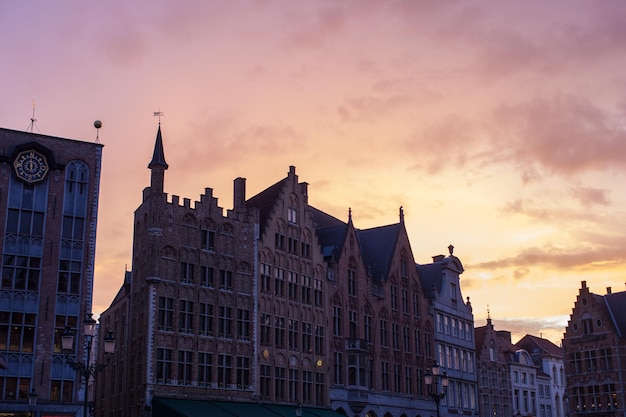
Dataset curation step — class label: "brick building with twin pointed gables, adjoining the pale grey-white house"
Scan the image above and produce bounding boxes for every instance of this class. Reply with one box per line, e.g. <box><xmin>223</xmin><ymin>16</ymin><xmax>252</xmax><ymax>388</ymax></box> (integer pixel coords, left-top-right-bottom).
<box><xmin>317</xmin><ymin>208</ymin><xmax>434</xmax><ymax>417</ymax></box>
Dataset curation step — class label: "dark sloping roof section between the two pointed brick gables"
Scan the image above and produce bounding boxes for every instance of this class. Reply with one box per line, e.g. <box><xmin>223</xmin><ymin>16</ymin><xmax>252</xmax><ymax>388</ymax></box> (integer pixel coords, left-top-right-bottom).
<box><xmin>357</xmin><ymin>223</ymin><xmax>401</xmax><ymax>282</ymax></box>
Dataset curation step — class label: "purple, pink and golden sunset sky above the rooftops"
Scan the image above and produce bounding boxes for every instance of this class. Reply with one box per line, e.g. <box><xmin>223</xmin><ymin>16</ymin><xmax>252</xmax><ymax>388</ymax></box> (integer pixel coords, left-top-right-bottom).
<box><xmin>0</xmin><ymin>0</ymin><xmax>626</xmax><ymax>344</ymax></box>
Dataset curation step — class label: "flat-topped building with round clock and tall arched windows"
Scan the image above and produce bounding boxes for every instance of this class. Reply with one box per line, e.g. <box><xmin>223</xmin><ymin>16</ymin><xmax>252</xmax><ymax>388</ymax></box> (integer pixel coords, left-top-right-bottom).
<box><xmin>0</xmin><ymin>129</ymin><xmax>102</xmax><ymax>416</ymax></box>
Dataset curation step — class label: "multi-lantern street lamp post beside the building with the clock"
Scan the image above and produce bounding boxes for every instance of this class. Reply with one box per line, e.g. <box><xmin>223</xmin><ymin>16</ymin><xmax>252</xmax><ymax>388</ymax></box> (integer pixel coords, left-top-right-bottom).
<box><xmin>61</xmin><ymin>313</ymin><xmax>115</xmax><ymax>417</ymax></box>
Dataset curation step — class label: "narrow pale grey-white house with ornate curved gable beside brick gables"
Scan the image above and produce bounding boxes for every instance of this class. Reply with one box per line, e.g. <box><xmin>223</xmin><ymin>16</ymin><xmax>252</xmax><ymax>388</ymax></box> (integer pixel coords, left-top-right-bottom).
<box><xmin>417</xmin><ymin>249</ymin><xmax>479</xmax><ymax>415</ymax></box>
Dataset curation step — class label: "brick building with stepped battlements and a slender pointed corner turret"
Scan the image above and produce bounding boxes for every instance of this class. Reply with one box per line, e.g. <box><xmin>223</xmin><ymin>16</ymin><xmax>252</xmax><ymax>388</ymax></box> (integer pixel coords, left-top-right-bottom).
<box><xmin>96</xmin><ymin>126</ymin><xmax>258</xmax><ymax>416</ymax></box>
